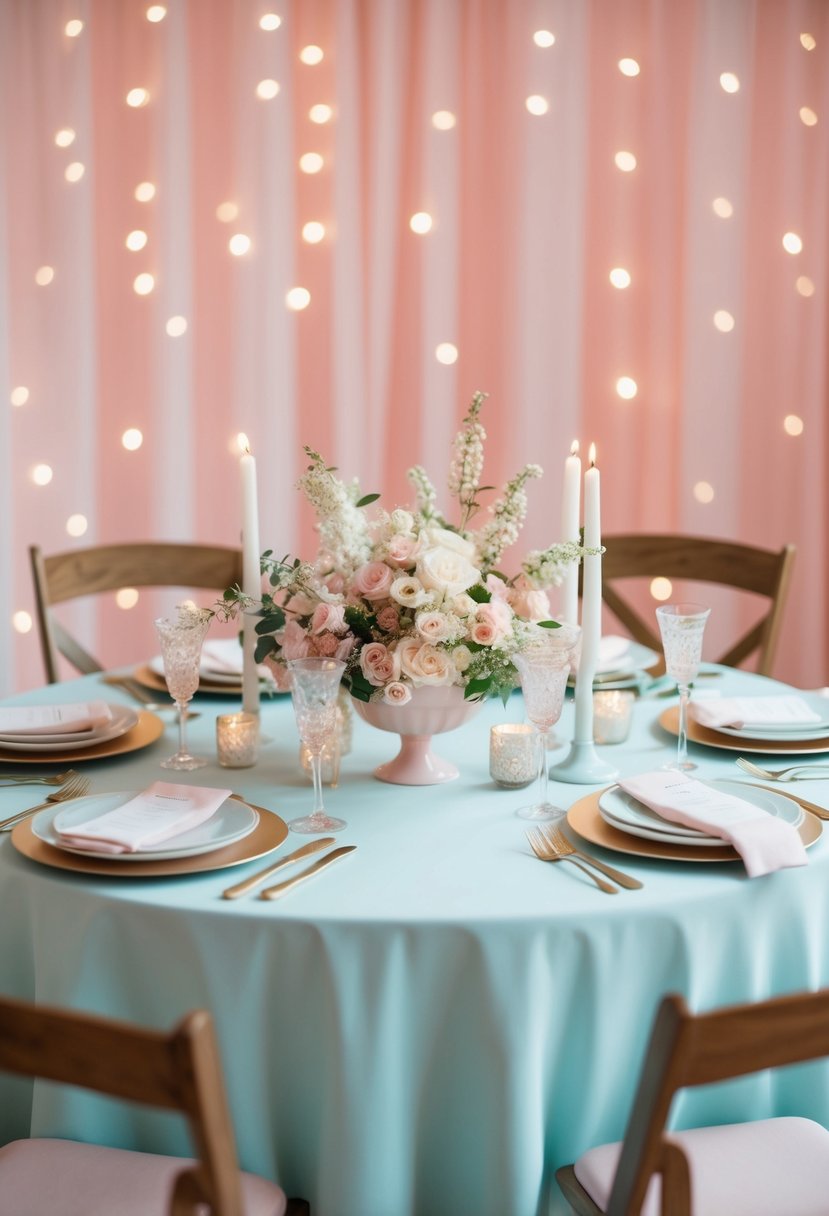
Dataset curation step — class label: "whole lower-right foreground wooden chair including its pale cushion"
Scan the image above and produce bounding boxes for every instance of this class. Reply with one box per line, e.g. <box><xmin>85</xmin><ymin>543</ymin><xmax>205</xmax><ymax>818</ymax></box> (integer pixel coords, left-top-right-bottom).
<box><xmin>556</xmin><ymin>990</ymin><xmax>829</xmax><ymax>1216</ymax></box>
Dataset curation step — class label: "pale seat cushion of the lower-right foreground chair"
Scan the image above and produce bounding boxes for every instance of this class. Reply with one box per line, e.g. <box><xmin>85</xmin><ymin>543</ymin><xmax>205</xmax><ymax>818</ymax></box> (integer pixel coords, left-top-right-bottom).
<box><xmin>574</xmin><ymin>1118</ymin><xmax>829</xmax><ymax>1216</ymax></box>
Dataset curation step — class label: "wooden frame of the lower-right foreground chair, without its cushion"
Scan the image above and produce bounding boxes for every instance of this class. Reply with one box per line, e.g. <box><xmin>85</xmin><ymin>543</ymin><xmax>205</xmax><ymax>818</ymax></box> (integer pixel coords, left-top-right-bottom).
<box><xmin>556</xmin><ymin>990</ymin><xmax>829</xmax><ymax>1216</ymax></box>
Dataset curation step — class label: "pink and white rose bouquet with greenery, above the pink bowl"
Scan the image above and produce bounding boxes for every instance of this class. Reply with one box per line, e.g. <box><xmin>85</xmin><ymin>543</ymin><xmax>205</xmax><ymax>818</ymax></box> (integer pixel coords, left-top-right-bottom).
<box><xmin>224</xmin><ymin>393</ymin><xmax>585</xmax><ymax>704</ymax></box>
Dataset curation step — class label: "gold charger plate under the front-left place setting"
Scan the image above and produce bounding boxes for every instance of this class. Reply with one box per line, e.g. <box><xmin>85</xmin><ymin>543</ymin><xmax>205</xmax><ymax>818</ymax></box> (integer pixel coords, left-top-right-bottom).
<box><xmin>11</xmin><ymin>804</ymin><xmax>288</xmax><ymax>878</ymax></box>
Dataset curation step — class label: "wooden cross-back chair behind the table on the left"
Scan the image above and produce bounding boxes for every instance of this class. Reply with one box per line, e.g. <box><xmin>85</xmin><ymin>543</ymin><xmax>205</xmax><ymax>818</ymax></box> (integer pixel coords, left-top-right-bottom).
<box><xmin>29</xmin><ymin>542</ymin><xmax>242</xmax><ymax>683</ymax></box>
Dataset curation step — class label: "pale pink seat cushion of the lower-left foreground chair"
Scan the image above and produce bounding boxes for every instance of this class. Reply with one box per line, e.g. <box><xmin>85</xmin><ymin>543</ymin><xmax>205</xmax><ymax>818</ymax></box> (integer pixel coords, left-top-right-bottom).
<box><xmin>0</xmin><ymin>1139</ymin><xmax>286</xmax><ymax>1216</ymax></box>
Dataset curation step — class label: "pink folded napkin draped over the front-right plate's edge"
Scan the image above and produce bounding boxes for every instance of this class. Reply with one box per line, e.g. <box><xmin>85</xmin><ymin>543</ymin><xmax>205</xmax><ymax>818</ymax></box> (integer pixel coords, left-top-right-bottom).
<box><xmin>619</xmin><ymin>771</ymin><xmax>808</xmax><ymax>878</ymax></box>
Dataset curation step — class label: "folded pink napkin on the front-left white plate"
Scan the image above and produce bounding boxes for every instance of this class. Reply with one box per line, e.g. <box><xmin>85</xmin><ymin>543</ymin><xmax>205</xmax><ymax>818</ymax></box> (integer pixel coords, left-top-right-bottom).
<box><xmin>56</xmin><ymin>781</ymin><xmax>231</xmax><ymax>852</ymax></box>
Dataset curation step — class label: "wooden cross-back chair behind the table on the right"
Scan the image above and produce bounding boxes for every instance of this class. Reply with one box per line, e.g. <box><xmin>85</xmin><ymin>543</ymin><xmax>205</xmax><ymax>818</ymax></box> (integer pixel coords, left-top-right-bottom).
<box><xmin>590</xmin><ymin>535</ymin><xmax>795</xmax><ymax>675</ymax></box>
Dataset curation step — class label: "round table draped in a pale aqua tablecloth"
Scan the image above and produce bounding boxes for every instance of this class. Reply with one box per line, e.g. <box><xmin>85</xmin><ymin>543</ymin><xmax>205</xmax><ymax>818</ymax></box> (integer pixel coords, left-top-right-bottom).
<box><xmin>0</xmin><ymin>669</ymin><xmax>829</xmax><ymax>1216</ymax></box>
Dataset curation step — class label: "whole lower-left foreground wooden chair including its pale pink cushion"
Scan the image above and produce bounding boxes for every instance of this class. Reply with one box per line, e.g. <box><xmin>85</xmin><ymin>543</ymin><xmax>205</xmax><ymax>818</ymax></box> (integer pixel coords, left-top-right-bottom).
<box><xmin>0</xmin><ymin>998</ymin><xmax>309</xmax><ymax>1216</ymax></box>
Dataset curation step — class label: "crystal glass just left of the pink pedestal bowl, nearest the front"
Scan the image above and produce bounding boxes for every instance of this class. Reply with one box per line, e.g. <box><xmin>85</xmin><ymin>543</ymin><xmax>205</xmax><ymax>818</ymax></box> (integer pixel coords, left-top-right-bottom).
<box><xmin>288</xmin><ymin>659</ymin><xmax>346</xmax><ymax>835</ymax></box>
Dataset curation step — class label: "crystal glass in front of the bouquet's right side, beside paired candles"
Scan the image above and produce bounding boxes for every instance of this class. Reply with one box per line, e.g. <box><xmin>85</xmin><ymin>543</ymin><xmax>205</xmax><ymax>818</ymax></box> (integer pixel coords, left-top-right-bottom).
<box><xmin>513</xmin><ymin>625</ymin><xmax>581</xmax><ymax>821</ymax></box>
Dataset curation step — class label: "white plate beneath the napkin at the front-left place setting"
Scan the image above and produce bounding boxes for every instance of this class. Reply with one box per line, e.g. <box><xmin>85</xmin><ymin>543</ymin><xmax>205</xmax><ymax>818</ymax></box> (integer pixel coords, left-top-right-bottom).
<box><xmin>32</xmin><ymin>790</ymin><xmax>259</xmax><ymax>863</ymax></box>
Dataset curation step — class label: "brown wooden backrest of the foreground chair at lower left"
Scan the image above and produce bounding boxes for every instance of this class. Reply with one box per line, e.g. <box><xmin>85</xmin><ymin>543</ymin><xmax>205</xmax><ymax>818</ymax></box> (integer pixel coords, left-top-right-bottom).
<box><xmin>0</xmin><ymin>997</ymin><xmax>243</xmax><ymax>1216</ymax></box>
